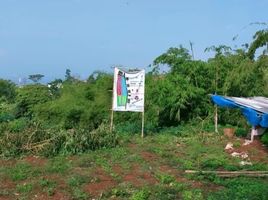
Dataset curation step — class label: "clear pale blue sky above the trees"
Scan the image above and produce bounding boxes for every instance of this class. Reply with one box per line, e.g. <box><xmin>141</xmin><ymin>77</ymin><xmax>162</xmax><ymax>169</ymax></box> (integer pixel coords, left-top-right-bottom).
<box><xmin>0</xmin><ymin>0</ymin><xmax>268</xmax><ymax>79</ymax></box>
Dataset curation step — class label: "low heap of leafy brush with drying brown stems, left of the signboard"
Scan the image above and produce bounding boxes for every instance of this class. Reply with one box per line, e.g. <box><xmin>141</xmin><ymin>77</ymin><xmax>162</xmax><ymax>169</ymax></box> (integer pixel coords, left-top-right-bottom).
<box><xmin>0</xmin><ymin>121</ymin><xmax>118</xmax><ymax>157</ymax></box>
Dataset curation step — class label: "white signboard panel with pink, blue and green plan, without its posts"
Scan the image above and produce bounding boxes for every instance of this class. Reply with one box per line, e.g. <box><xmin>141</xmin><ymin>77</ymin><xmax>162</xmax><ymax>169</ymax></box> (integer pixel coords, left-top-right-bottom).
<box><xmin>113</xmin><ymin>68</ymin><xmax>145</xmax><ymax>112</ymax></box>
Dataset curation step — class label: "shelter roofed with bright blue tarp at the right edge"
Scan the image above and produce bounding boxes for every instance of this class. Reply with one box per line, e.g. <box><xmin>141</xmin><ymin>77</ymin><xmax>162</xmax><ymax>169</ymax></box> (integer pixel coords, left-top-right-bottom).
<box><xmin>211</xmin><ymin>95</ymin><xmax>268</xmax><ymax>140</ymax></box>
